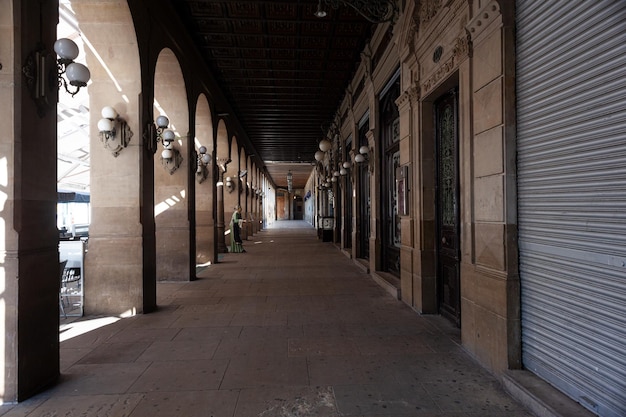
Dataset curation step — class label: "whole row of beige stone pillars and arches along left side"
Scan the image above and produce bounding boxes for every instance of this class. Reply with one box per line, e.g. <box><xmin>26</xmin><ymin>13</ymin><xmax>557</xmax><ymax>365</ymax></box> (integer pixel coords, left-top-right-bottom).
<box><xmin>0</xmin><ymin>0</ymin><xmax>272</xmax><ymax>402</ymax></box>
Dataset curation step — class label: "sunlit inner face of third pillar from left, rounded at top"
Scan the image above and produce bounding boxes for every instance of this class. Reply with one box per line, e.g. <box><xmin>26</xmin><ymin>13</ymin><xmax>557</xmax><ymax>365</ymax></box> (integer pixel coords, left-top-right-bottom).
<box><xmin>154</xmin><ymin>48</ymin><xmax>192</xmax><ymax>281</ymax></box>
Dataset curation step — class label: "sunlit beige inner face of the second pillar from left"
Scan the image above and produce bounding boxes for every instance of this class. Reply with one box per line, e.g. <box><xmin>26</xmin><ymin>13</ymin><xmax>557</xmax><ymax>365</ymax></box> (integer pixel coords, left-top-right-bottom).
<box><xmin>74</xmin><ymin>1</ymin><xmax>147</xmax><ymax>315</ymax></box>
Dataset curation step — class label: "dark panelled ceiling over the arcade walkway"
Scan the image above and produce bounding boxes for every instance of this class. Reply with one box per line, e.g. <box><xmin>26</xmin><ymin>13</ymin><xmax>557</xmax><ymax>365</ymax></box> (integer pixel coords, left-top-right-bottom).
<box><xmin>172</xmin><ymin>0</ymin><xmax>374</xmax><ymax>188</ymax></box>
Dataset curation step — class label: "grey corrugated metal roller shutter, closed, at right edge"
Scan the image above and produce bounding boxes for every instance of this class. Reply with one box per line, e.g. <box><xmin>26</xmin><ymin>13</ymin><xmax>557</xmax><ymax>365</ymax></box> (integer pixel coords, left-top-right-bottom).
<box><xmin>516</xmin><ymin>0</ymin><xmax>626</xmax><ymax>417</ymax></box>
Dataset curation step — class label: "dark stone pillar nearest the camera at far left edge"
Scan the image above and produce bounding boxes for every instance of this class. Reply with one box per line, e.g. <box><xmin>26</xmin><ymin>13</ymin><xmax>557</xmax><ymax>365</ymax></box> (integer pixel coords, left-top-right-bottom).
<box><xmin>0</xmin><ymin>1</ymin><xmax>59</xmax><ymax>402</ymax></box>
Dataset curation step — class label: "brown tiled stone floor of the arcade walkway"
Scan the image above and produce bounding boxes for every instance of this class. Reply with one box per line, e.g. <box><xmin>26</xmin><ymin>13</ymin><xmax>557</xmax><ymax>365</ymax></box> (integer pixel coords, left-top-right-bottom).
<box><xmin>0</xmin><ymin>222</ymin><xmax>531</xmax><ymax>417</ymax></box>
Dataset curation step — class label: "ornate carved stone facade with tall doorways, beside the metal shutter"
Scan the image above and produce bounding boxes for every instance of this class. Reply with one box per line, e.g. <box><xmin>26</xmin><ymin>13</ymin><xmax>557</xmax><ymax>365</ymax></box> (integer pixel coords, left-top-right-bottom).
<box><xmin>332</xmin><ymin>0</ymin><xmax>520</xmax><ymax>372</ymax></box>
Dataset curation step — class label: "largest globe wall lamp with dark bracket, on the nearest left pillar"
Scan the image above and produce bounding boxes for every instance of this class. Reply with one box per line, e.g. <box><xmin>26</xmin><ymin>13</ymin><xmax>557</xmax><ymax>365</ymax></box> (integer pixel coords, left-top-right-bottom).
<box><xmin>22</xmin><ymin>38</ymin><xmax>91</xmax><ymax>117</ymax></box>
